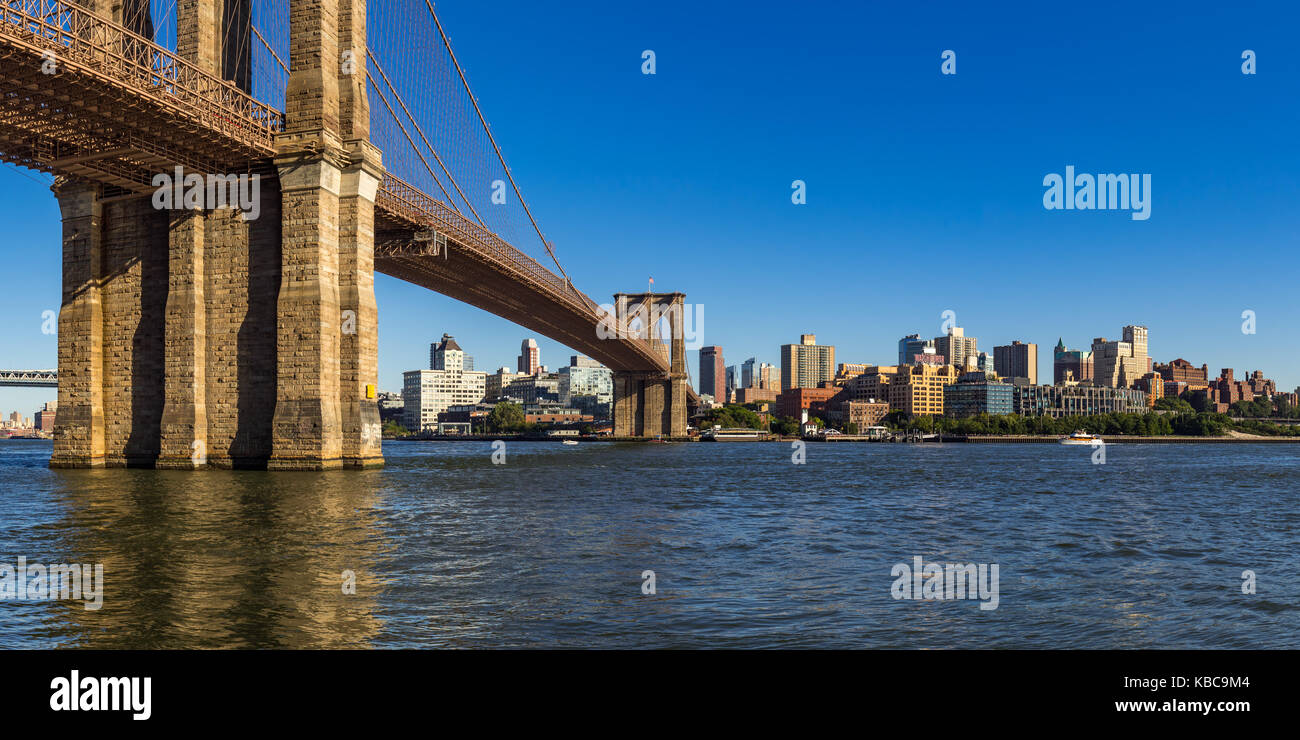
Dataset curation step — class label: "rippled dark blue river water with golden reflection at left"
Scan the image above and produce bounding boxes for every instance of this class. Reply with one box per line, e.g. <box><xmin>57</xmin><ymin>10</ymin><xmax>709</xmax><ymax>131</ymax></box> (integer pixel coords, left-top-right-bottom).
<box><xmin>0</xmin><ymin>441</ymin><xmax>1300</xmax><ymax>648</ymax></box>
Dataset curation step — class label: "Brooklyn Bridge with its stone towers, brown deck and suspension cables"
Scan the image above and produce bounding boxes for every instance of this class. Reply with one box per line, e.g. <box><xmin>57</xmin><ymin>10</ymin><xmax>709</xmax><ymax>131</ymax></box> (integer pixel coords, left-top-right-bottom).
<box><xmin>0</xmin><ymin>0</ymin><xmax>697</xmax><ymax>469</ymax></box>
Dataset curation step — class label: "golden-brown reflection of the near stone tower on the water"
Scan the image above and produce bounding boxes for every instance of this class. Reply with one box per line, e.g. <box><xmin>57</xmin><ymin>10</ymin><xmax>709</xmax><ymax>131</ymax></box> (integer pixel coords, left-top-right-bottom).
<box><xmin>3</xmin><ymin>442</ymin><xmax>386</xmax><ymax>648</ymax></box>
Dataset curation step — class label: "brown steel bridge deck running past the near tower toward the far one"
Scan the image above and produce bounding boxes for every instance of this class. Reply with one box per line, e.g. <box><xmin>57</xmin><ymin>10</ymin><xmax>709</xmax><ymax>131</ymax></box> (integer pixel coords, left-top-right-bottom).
<box><xmin>0</xmin><ymin>0</ymin><xmax>691</xmax><ymax>387</ymax></box>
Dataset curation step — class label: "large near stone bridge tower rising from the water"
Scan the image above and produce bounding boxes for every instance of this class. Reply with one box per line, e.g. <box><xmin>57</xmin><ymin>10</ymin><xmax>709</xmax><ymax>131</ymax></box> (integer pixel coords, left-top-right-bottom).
<box><xmin>51</xmin><ymin>0</ymin><xmax>384</xmax><ymax>469</ymax></box>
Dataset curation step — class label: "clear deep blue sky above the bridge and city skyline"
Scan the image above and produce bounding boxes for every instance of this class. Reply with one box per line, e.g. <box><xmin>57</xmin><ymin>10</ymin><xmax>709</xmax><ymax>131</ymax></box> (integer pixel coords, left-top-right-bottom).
<box><xmin>0</xmin><ymin>0</ymin><xmax>1300</xmax><ymax>414</ymax></box>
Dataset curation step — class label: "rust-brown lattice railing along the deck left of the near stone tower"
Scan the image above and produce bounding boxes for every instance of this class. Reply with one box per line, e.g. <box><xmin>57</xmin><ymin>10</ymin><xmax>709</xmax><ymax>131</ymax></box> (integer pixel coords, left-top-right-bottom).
<box><xmin>0</xmin><ymin>0</ymin><xmax>285</xmax><ymax>151</ymax></box>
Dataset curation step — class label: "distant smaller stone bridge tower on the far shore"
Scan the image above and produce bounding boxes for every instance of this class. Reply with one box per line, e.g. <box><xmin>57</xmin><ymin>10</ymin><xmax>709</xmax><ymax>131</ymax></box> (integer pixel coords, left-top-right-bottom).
<box><xmin>614</xmin><ymin>293</ymin><xmax>689</xmax><ymax>437</ymax></box>
